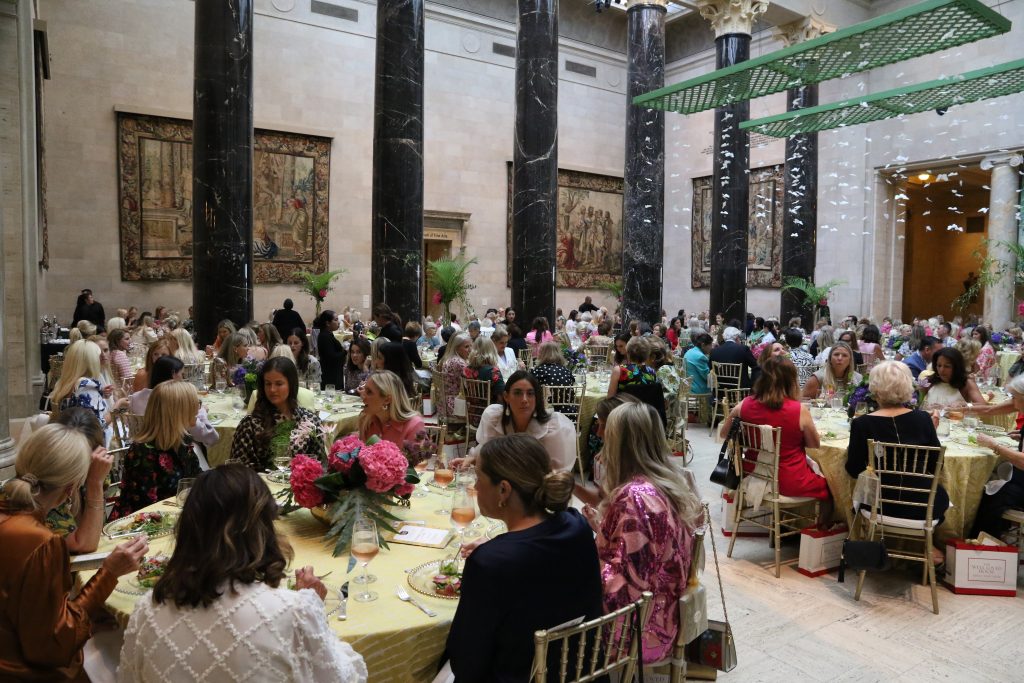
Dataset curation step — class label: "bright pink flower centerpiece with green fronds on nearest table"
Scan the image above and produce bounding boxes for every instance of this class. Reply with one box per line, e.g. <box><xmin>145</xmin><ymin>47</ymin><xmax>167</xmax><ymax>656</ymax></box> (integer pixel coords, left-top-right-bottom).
<box><xmin>279</xmin><ymin>434</ymin><xmax>420</xmax><ymax>557</ymax></box>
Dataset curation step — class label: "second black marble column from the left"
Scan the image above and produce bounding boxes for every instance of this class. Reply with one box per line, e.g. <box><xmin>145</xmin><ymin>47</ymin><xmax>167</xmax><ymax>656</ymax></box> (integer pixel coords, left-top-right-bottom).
<box><xmin>371</xmin><ymin>0</ymin><xmax>424</xmax><ymax>321</ymax></box>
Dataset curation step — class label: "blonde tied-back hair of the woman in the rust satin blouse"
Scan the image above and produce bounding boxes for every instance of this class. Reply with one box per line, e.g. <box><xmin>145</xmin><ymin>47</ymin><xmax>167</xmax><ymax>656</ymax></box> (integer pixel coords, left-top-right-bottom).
<box><xmin>3</xmin><ymin>423</ymin><xmax>92</xmax><ymax>512</ymax></box>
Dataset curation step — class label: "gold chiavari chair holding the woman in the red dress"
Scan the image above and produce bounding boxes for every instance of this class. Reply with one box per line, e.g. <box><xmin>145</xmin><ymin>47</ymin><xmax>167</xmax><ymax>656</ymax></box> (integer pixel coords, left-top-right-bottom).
<box><xmin>727</xmin><ymin>422</ymin><xmax>818</xmax><ymax>579</ymax></box>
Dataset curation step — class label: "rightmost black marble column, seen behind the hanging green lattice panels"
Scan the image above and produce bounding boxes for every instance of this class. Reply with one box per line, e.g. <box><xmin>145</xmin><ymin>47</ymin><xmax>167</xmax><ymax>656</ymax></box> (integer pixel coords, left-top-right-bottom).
<box><xmin>781</xmin><ymin>85</ymin><xmax>818</xmax><ymax>329</ymax></box>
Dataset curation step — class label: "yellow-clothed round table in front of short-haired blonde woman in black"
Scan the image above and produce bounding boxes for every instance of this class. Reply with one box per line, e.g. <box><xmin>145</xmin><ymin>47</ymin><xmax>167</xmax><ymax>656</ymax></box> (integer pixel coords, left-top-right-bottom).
<box><xmin>807</xmin><ymin>410</ymin><xmax>1003</xmax><ymax>542</ymax></box>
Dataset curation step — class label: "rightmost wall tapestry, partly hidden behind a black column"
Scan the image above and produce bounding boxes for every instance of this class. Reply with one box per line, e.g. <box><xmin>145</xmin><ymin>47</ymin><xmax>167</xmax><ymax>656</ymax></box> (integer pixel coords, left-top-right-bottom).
<box><xmin>690</xmin><ymin>165</ymin><xmax>785</xmax><ymax>289</ymax></box>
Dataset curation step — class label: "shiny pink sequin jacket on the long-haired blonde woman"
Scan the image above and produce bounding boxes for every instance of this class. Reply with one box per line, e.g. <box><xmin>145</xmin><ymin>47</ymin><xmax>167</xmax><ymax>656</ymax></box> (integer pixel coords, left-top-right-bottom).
<box><xmin>597</xmin><ymin>477</ymin><xmax>693</xmax><ymax>664</ymax></box>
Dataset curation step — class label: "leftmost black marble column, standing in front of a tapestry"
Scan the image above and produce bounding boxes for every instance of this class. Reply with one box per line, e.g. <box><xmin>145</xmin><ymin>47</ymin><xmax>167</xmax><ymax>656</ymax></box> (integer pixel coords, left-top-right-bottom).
<box><xmin>193</xmin><ymin>0</ymin><xmax>253</xmax><ymax>344</ymax></box>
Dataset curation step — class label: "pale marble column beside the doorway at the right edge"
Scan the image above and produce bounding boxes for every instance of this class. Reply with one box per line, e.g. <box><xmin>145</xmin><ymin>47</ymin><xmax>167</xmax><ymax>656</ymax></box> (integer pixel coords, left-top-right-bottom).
<box><xmin>981</xmin><ymin>153</ymin><xmax>1022</xmax><ymax>330</ymax></box>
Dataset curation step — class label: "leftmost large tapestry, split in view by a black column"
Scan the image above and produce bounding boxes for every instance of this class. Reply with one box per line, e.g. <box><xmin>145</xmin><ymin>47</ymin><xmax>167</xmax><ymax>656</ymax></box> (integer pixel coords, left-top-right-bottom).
<box><xmin>118</xmin><ymin>112</ymin><xmax>331</xmax><ymax>285</ymax></box>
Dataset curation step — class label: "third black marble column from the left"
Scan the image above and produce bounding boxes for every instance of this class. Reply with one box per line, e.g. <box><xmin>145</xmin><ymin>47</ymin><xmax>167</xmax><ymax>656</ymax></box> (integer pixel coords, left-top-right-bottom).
<box><xmin>512</xmin><ymin>0</ymin><xmax>558</xmax><ymax>328</ymax></box>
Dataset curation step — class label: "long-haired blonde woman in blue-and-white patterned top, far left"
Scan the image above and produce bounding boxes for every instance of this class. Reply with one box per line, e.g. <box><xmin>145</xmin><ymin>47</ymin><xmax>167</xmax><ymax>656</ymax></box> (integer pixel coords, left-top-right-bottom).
<box><xmin>50</xmin><ymin>339</ymin><xmax>128</xmax><ymax>442</ymax></box>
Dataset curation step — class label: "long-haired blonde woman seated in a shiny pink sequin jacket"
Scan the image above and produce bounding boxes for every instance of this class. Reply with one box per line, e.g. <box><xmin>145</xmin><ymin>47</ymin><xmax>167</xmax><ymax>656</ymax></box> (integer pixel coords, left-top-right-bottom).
<box><xmin>584</xmin><ymin>403</ymin><xmax>701</xmax><ymax>664</ymax></box>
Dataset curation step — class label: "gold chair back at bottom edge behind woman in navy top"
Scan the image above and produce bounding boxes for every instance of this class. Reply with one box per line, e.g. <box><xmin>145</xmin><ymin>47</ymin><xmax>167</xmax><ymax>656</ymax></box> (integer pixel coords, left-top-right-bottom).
<box><xmin>530</xmin><ymin>591</ymin><xmax>653</xmax><ymax>683</ymax></box>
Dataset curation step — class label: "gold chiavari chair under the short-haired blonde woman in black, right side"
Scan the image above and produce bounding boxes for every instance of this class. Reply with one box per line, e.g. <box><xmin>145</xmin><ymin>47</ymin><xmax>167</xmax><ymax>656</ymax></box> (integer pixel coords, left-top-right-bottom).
<box><xmin>853</xmin><ymin>439</ymin><xmax>946</xmax><ymax>614</ymax></box>
